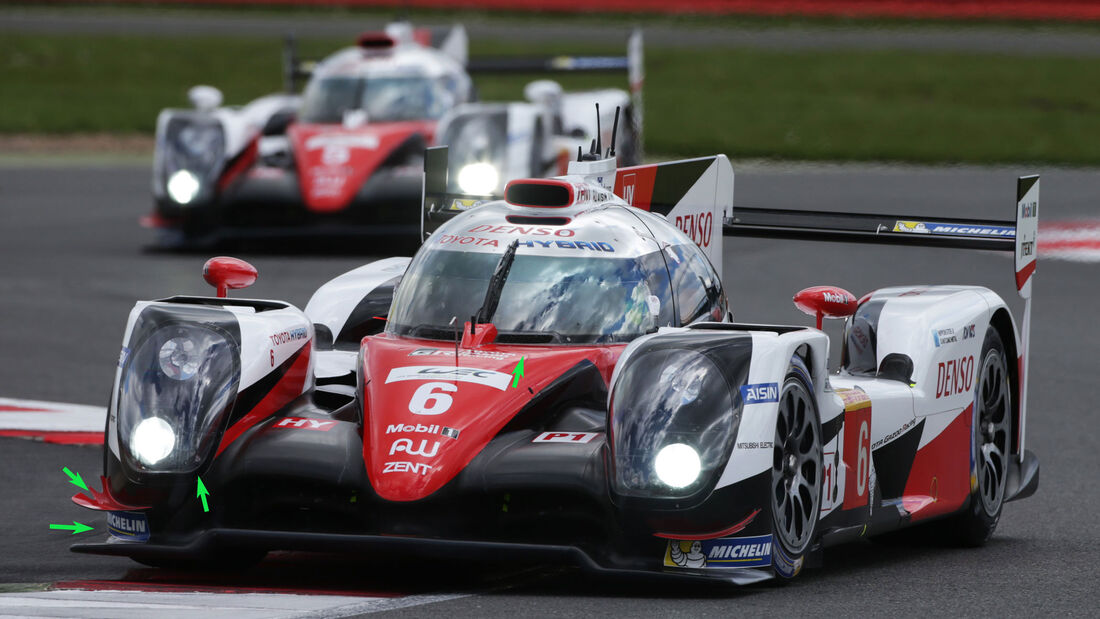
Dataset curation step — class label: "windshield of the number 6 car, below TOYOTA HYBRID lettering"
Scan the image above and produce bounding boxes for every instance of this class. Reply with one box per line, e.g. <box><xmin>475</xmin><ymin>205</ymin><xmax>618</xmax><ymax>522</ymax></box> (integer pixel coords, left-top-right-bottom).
<box><xmin>387</xmin><ymin>247</ymin><xmax>673</xmax><ymax>344</ymax></box>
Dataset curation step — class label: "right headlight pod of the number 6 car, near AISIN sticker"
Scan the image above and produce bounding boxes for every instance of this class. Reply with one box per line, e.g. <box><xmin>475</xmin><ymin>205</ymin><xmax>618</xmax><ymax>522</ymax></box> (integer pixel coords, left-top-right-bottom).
<box><xmin>611</xmin><ymin>347</ymin><xmax>740</xmax><ymax>498</ymax></box>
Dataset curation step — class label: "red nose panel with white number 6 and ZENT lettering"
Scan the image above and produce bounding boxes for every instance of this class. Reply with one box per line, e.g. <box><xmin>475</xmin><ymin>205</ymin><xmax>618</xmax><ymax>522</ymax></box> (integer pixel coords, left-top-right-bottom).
<box><xmin>362</xmin><ymin>334</ymin><xmax>625</xmax><ymax>501</ymax></box>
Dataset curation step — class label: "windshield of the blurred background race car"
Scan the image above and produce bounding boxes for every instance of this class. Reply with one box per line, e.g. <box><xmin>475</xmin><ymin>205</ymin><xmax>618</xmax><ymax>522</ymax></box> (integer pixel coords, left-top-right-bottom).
<box><xmin>301</xmin><ymin>76</ymin><xmax>458</xmax><ymax>123</ymax></box>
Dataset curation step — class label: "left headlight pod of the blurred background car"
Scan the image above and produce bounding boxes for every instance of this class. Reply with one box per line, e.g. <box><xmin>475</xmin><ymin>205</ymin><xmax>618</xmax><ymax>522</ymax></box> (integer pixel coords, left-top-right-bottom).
<box><xmin>157</xmin><ymin>115</ymin><xmax>226</xmax><ymax>206</ymax></box>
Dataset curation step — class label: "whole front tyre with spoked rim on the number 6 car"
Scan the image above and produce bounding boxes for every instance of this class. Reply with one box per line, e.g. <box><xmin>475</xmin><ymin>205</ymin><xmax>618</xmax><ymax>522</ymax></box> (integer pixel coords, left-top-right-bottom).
<box><xmin>769</xmin><ymin>355</ymin><xmax>824</xmax><ymax>578</ymax></box>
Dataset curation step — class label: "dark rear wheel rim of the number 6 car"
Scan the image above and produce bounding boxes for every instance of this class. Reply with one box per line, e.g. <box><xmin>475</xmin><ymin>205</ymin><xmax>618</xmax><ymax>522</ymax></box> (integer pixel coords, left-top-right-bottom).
<box><xmin>975</xmin><ymin>351</ymin><xmax>1012</xmax><ymax>516</ymax></box>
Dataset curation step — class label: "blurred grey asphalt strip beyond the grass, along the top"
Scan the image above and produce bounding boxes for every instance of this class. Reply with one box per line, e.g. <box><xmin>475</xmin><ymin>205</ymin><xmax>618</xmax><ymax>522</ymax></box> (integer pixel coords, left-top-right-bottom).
<box><xmin>0</xmin><ymin>8</ymin><xmax>1100</xmax><ymax>57</ymax></box>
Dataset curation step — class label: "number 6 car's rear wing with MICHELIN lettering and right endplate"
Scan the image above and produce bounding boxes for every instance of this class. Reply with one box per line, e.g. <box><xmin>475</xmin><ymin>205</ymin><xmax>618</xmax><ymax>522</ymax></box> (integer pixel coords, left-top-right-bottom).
<box><xmin>723</xmin><ymin>175</ymin><xmax>1040</xmax><ymax>458</ymax></box>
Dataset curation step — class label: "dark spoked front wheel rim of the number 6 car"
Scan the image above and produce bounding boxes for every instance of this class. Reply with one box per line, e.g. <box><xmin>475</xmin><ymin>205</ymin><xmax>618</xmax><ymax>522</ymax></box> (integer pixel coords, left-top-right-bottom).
<box><xmin>771</xmin><ymin>380</ymin><xmax>822</xmax><ymax>554</ymax></box>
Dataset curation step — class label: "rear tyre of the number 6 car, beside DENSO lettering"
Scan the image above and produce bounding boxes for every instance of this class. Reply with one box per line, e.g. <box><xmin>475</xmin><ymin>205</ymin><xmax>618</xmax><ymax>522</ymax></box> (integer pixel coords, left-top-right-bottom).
<box><xmin>934</xmin><ymin>325</ymin><xmax>1014</xmax><ymax>548</ymax></box>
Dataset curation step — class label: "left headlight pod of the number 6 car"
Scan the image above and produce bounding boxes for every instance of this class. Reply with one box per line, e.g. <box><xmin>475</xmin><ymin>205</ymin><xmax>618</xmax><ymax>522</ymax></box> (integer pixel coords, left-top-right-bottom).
<box><xmin>118</xmin><ymin>323</ymin><xmax>240</xmax><ymax>474</ymax></box>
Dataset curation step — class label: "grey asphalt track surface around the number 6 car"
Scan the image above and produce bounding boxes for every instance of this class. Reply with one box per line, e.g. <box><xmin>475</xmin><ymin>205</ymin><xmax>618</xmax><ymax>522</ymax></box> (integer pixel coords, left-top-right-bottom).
<box><xmin>0</xmin><ymin>165</ymin><xmax>1100</xmax><ymax>617</ymax></box>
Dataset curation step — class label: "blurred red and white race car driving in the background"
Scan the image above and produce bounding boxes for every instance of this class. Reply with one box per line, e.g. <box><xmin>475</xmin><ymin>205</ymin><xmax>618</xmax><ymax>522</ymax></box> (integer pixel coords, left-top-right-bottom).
<box><xmin>142</xmin><ymin>22</ymin><xmax>642</xmax><ymax>246</ymax></box>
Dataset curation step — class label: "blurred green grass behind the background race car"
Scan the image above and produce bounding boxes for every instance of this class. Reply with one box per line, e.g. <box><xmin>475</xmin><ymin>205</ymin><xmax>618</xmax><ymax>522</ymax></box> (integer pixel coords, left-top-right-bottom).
<box><xmin>0</xmin><ymin>33</ymin><xmax>1100</xmax><ymax>165</ymax></box>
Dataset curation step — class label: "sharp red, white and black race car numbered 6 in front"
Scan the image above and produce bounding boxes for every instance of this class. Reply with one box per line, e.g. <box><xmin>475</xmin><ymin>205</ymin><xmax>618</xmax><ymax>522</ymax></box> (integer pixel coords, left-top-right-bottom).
<box><xmin>73</xmin><ymin>124</ymin><xmax>1038</xmax><ymax>583</ymax></box>
